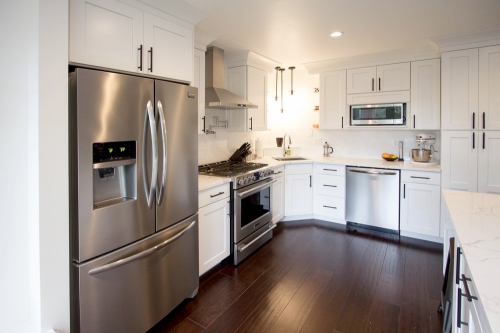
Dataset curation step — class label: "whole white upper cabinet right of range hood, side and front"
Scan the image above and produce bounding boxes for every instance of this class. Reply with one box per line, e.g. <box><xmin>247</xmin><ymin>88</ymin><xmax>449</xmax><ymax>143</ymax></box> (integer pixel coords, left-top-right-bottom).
<box><xmin>227</xmin><ymin>66</ymin><xmax>267</xmax><ymax>132</ymax></box>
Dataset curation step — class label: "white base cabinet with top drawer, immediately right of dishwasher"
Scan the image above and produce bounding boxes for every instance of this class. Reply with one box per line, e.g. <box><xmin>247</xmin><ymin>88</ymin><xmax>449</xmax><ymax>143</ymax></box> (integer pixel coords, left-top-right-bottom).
<box><xmin>399</xmin><ymin>170</ymin><xmax>441</xmax><ymax>237</ymax></box>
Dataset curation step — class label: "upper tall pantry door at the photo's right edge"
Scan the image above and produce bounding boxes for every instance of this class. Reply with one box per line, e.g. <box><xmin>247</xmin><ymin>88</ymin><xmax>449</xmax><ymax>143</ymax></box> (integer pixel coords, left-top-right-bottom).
<box><xmin>479</xmin><ymin>45</ymin><xmax>500</xmax><ymax>130</ymax></box>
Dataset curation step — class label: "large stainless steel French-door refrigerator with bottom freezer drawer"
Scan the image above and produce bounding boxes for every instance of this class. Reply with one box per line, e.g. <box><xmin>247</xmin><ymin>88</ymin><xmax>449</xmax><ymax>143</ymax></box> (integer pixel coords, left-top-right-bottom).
<box><xmin>69</xmin><ymin>68</ymin><xmax>199</xmax><ymax>333</ymax></box>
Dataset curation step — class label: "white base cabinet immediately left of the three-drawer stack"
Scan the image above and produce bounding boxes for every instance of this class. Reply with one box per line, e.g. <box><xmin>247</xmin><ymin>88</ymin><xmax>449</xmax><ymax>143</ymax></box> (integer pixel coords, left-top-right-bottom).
<box><xmin>285</xmin><ymin>164</ymin><xmax>313</xmax><ymax>216</ymax></box>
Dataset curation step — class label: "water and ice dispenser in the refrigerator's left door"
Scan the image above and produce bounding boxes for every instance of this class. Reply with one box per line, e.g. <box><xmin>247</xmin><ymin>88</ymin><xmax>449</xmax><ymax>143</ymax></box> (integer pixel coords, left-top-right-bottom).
<box><xmin>92</xmin><ymin>141</ymin><xmax>137</xmax><ymax>209</ymax></box>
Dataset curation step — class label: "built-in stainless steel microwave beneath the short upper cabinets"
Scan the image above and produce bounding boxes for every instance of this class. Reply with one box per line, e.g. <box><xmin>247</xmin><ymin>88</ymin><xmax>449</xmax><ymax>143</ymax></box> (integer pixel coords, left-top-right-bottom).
<box><xmin>350</xmin><ymin>103</ymin><xmax>406</xmax><ymax>126</ymax></box>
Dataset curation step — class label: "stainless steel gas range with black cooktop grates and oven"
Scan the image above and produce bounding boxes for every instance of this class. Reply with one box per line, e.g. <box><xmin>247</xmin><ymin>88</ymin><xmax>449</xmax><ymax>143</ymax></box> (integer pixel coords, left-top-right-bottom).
<box><xmin>198</xmin><ymin>160</ymin><xmax>275</xmax><ymax>265</ymax></box>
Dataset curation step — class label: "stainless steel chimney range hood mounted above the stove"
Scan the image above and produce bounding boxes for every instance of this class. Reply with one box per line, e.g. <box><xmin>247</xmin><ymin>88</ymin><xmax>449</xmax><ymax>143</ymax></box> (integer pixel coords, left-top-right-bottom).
<box><xmin>205</xmin><ymin>46</ymin><xmax>257</xmax><ymax>110</ymax></box>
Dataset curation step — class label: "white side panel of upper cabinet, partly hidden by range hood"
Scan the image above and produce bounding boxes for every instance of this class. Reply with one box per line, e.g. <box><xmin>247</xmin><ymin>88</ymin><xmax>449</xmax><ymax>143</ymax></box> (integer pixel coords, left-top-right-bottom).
<box><xmin>227</xmin><ymin>66</ymin><xmax>248</xmax><ymax>132</ymax></box>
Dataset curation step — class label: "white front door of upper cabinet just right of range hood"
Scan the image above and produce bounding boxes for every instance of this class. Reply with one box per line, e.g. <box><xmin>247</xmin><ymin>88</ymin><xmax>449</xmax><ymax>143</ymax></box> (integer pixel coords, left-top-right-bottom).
<box><xmin>247</xmin><ymin>67</ymin><xmax>267</xmax><ymax>131</ymax></box>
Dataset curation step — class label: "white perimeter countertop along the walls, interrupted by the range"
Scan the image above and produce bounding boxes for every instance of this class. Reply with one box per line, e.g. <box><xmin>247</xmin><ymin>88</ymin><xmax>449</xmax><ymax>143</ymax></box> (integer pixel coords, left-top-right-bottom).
<box><xmin>198</xmin><ymin>156</ymin><xmax>441</xmax><ymax>191</ymax></box>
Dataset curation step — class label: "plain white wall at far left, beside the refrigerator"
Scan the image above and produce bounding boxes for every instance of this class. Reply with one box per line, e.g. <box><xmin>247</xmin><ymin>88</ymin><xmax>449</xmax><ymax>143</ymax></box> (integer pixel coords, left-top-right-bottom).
<box><xmin>0</xmin><ymin>0</ymin><xmax>69</xmax><ymax>332</ymax></box>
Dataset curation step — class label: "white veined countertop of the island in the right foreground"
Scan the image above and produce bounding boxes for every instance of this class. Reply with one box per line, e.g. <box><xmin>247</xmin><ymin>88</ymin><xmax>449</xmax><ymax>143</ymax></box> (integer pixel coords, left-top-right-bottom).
<box><xmin>443</xmin><ymin>190</ymin><xmax>500</xmax><ymax>332</ymax></box>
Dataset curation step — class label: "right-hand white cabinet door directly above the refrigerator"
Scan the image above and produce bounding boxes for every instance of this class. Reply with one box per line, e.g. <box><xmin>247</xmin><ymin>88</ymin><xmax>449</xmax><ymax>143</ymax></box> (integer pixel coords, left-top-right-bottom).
<box><xmin>144</xmin><ymin>13</ymin><xmax>194</xmax><ymax>82</ymax></box>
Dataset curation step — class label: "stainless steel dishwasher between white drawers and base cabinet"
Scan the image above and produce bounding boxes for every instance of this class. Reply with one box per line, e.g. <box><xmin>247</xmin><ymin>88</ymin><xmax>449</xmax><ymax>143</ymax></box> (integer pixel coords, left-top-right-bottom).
<box><xmin>346</xmin><ymin>166</ymin><xmax>399</xmax><ymax>234</ymax></box>
